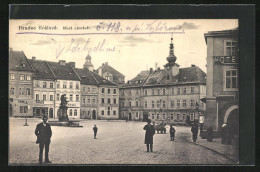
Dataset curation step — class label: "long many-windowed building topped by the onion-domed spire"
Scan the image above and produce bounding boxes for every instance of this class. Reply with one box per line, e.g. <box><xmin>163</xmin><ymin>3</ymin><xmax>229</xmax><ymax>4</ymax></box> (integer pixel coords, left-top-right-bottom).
<box><xmin>120</xmin><ymin>37</ymin><xmax>206</xmax><ymax>124</ymax></box>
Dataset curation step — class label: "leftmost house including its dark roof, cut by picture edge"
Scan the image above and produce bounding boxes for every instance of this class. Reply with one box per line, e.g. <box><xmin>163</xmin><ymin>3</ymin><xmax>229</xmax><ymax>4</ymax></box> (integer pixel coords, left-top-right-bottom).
<box><xmin>9</xmin><ymin>49</ymin><xmax>33</xmax><ymax>117</ymax></box>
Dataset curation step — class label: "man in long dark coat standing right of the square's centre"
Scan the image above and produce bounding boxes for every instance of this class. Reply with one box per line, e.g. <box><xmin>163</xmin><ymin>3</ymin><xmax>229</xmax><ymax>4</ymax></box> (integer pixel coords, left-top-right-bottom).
<box><xmin>144</xmin><ymin>119</ymin><xmax>155</xmax><ymax>152</ymax></box>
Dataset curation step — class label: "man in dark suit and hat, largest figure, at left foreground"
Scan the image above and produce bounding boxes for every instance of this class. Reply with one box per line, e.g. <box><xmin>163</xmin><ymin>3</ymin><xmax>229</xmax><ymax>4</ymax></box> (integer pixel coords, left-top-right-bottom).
<box><xmin>35</xmin><ymin>116</ymin><xmax>52</xmax><ymax>164</ymax></box>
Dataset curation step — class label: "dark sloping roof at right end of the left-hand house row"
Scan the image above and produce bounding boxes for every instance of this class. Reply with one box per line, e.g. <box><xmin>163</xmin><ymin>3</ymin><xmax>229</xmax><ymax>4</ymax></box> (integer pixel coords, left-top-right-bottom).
<box><xmin>75</xmin><ymin>68</ymin><xmax>116</xmax><ymax>86</ymax></box>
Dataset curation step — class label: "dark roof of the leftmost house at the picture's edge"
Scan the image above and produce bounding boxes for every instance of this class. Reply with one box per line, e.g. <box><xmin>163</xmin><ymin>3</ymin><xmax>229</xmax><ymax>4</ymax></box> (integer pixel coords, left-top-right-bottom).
<box><xmin>9</xmin><ymin>50</ymin><xmax>33</xmax><ymax>72</ymax></box>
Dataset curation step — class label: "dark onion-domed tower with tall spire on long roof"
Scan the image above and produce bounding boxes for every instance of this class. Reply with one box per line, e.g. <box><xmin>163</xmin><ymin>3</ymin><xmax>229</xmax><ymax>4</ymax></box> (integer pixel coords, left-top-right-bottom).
<box><xmin>164</xmin><ymin>37</ymin><xmax>179</xmax><ymax>82</ymax></box>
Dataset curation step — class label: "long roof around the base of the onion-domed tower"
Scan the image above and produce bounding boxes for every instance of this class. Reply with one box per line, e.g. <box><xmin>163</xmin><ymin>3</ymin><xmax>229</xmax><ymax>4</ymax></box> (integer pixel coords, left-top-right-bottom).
<box><xmin>122</xmin><ymin>66</ymin><xmax>206</xmax><ymax>88</ymax></box>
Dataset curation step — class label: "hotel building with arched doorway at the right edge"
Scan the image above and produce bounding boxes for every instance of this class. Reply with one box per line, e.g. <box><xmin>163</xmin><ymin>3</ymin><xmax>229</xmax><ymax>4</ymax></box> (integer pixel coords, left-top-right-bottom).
<box><xmin>204</xmin><ymin>29</ymin><xmax>239</xmax><ymax>138</ymax></box>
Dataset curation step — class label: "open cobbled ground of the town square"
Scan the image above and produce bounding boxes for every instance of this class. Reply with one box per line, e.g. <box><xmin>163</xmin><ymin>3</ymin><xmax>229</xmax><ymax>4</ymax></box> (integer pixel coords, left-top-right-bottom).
<box><xmin>9</xmin><ymin>118</ymin><xmax>233</xmax><ymax>165</ymax></box>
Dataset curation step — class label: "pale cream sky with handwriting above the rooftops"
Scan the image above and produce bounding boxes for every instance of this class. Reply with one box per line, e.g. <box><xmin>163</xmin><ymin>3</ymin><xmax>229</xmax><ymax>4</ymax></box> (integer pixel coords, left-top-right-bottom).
<box><xmin>9</xmin><ymin>19</ymin><xmax>238</xmax><ymax>81</ymax></box>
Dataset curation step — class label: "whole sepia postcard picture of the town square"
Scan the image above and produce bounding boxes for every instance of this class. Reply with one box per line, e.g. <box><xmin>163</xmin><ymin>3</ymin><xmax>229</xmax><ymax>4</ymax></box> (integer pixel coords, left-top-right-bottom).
<box><xmin>8</xmin><ymin>18</ymin><xmax>240</xmax><ymax>166</ymax></box>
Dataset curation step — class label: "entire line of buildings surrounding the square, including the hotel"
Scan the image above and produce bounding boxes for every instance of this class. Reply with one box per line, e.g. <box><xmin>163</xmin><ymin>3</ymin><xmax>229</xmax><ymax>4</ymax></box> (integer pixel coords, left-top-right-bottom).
<box><xmin>9</xmin><ymin>26</ymin><xmax>239</xmax><ymax>137</ymax></box>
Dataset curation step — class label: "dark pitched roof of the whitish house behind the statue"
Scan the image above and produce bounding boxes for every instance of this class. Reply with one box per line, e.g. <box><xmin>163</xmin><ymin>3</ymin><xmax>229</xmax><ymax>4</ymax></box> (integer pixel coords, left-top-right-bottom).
<box><xmin>47</xmin><ymin>61</ymin><xmax>80</xmax><ymax>81</ymax></box>
